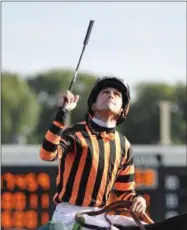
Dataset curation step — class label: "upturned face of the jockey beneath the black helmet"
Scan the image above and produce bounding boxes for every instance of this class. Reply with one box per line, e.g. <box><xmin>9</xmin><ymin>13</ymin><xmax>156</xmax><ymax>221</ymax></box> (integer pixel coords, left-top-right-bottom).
<box><xmin>92</xmin><ymin>88</ymin><xmax>123</xmax><ymax>115</ymax></box>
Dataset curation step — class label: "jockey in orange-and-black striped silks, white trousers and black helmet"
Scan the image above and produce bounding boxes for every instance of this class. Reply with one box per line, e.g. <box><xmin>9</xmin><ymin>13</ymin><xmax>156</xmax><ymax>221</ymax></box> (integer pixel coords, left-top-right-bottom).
<box><xmin>40</xmin><ymin>76</ymin><xmax>146</xmax><ymax>229</ymax></box>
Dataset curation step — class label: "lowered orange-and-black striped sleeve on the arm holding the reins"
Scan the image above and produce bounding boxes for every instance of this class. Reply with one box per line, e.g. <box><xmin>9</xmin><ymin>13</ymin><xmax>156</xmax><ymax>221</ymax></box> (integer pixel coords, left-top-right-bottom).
<box><xmin>114</xmin><ymin>138</ymin><xmax>136</xmax><ymax>200</ymax></box>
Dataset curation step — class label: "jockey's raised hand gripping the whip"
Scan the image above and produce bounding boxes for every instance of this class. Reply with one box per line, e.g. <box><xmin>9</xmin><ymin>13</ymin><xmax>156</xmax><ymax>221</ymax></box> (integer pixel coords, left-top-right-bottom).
<box><xmin>58</xmin><ymin>90</ymin><xmax>79</xmax><ymax>111</ymax></box>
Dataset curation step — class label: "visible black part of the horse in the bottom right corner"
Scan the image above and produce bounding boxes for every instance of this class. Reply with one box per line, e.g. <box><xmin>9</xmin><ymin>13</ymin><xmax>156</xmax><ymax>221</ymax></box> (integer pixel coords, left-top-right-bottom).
<box><xmin>115</xmin><ymin>213</ymin><xmax>187</xmax><ymax>230</ymax></box>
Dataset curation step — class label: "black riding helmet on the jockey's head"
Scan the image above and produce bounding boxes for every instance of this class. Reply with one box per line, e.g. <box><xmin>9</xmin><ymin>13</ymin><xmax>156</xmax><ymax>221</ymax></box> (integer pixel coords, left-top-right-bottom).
<box><xmin>88</xmin><ymin>76</ymin><xmax>130</xmax><ymax>125</ymax></box>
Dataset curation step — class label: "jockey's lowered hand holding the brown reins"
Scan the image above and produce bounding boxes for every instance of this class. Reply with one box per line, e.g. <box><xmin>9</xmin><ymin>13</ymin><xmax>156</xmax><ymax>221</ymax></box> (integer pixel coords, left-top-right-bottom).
<box><xmin>131</xmin><ymin>196</ymin><xmax>147</xmax><ymax>214</ymax></box>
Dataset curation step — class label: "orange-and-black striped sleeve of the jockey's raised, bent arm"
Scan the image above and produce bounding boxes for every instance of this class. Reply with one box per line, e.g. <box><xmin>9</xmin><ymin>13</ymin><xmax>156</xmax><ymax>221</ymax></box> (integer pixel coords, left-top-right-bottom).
<box><xmin>39</xmin><ymin>111</ymin><xmax>74</xmax><ymax>161</ymax></box>
